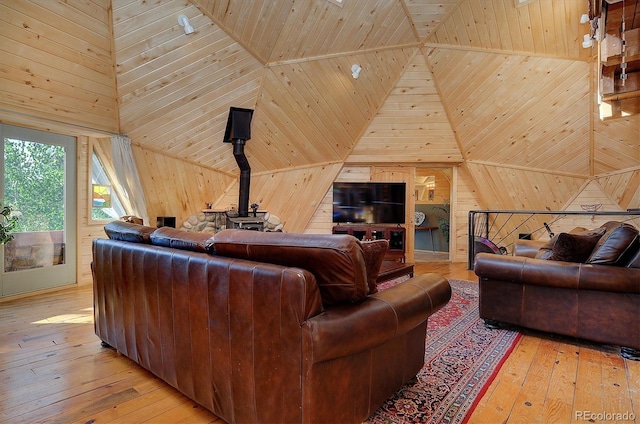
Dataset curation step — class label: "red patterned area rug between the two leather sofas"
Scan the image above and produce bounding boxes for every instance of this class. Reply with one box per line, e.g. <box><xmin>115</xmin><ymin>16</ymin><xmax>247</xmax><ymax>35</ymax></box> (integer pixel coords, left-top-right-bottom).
<box><xmin>366</xmin><ymin>278</ymin><xmax>520</xmax><ymax>424</ymax></box>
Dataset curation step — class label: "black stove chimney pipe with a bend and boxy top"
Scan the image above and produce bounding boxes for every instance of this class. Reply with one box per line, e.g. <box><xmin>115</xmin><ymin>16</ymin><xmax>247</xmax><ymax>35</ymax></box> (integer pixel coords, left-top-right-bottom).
<box><xmin>223</xmin><ymin>107</ymin><xmax>253</xmax><ymax>217</ymax></box>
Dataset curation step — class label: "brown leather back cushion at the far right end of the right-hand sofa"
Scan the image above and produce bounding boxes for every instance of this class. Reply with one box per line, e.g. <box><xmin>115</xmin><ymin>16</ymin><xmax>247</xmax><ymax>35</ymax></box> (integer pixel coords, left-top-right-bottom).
<box><xmin>586</xmin><ymin>221</ymin><xmax>638</xmax><ymax>265</ymax></box>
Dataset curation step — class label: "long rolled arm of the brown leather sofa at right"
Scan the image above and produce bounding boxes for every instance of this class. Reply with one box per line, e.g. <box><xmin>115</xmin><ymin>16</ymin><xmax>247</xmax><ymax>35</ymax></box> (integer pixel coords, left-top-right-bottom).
<box><xmin>474</xmin><ymin>253</ymin><xmax>640</xmax><ymax>293</ymax></box>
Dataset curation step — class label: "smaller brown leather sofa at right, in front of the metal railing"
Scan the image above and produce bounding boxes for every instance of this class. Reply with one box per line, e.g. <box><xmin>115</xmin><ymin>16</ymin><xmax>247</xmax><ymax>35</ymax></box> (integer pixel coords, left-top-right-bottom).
<box><xmin>474</xmin><ymin>221</ymin><xmax>640</xmax><ymax>359</ymax></box>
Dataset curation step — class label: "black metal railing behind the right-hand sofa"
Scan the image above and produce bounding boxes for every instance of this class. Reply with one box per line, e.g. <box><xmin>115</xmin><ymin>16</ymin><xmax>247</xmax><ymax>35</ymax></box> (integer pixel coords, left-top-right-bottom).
<box><xmin>468</xmin><ymin>209</ymin><xmax>640</xmax><ymax>269</ymax></box>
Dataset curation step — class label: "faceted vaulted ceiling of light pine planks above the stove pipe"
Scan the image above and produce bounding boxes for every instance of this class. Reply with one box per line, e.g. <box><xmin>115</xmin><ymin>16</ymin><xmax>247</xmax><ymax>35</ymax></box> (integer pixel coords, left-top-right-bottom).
<box><xmin>113</xmin><ymin>0</ymin><xmax>640</xmax><ymax>181</ymax></box>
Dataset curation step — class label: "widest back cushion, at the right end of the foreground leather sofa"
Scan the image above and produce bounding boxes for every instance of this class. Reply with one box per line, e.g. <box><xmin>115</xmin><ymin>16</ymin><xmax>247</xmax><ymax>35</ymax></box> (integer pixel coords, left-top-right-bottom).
<box><xmin>214</xmin><ymin>230</ymin><xmax>368</xmax><ymax>305</ymax></box>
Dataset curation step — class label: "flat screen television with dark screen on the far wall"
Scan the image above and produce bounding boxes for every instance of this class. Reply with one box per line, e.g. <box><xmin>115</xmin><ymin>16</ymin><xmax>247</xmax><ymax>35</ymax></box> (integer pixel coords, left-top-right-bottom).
<box><xmin>333</xmin><ymin>182</ymin><xmax>407</xmax><ymax>224</ymax></box>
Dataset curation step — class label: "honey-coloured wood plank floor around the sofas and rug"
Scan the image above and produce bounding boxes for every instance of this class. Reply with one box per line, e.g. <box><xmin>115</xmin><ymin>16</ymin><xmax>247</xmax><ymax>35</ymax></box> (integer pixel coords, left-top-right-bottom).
<box><xmin>0</xmin><ymin>263</ymin><xmax>640</xmax><ymax>423</ymax></box>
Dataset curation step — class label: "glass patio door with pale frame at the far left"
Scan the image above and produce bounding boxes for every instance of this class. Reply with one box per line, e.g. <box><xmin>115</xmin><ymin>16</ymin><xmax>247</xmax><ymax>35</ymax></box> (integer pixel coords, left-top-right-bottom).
<box><xmin>0</xmin><ymin>124</ymin><xmax>76</xmax><ymax>297</ymax></box>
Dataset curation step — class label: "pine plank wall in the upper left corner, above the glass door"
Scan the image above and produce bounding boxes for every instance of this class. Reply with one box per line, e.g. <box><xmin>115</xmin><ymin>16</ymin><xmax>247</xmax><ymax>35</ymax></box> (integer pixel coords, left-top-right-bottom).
<box><xmin>0</xmin><ymin>1</ymin><xmax>118</xmax><ymax>133</ymax></box>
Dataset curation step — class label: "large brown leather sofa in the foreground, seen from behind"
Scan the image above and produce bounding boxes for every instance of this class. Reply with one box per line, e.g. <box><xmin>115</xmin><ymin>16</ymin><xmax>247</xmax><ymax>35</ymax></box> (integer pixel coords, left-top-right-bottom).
<box><xmin>92</xmin><ymin>222</ymin><xmax>451</xmax><ymax>423</ymax></box>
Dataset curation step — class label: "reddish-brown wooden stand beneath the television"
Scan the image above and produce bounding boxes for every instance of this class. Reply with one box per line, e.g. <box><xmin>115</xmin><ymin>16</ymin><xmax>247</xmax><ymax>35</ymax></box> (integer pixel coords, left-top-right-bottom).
<box><xmin>332</xmin><ymin>224</ymin><xmax>413</xmax><ymax>268</ymax></box>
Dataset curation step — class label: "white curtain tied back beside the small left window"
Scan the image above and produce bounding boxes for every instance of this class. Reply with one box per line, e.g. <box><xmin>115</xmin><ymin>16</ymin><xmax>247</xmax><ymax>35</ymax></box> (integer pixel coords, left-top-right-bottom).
<box><xmin>111</xmin><ymin>135</ymin><xmax>150</xmax><ymax>225</ymax></box>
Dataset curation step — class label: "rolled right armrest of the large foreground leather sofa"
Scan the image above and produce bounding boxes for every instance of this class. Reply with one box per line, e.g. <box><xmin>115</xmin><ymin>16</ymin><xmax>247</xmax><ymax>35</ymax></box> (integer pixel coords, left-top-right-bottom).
<box><xmin>306</xmin><ymin>274</ymin><xmax>451</xmax><ymax>363</ymax></box>
